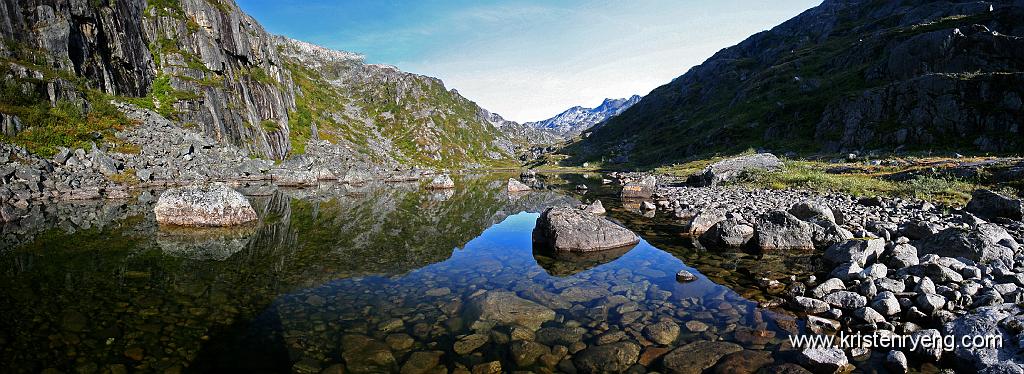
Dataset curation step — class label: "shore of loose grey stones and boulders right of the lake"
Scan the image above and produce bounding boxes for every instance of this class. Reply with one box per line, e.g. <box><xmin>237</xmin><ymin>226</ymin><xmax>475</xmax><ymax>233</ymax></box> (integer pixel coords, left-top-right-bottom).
<box><xmin>614</xmin><ymin>170</ymin><xmax>1024</xmax><ymax>373</ymax></box>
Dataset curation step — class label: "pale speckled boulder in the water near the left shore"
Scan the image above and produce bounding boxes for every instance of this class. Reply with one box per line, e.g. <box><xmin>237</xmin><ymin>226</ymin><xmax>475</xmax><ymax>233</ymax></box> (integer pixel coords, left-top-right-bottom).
<box><xmin>153</xmin><ymin>183</ymin><xmax>257</xmax><ymax>226</ymax></box>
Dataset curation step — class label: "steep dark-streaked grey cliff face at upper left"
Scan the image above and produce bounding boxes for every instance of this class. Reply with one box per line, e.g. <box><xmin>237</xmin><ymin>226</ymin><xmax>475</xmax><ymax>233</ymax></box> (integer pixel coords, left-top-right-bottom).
<box><xmin>0</xmin><ymin>0</ymin><xmax>294</xmax><ymax>159</ymax></box>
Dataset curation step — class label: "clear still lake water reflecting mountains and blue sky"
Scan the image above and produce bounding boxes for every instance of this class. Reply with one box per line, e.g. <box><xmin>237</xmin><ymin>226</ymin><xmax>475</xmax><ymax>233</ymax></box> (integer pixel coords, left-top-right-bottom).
<box><xmin>0</xmin><ymin>175</ymin><xmax>831</xmax><ymax>372</ymax></box>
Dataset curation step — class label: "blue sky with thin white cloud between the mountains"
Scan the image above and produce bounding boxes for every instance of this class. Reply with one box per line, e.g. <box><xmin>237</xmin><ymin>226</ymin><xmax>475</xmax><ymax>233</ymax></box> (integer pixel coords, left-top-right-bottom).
<box><xmin>237</xmin><ymin>0</ymin><xmax>821</xmax><ymax>122</ymax></box>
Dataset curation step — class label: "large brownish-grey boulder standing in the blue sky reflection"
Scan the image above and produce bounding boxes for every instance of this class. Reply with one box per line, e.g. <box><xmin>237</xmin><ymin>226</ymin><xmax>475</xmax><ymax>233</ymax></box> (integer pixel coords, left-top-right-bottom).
<box><xmin>534</xmin><ymin>207</ymin><xmax>640</xmax><ymax>252</ymax></box>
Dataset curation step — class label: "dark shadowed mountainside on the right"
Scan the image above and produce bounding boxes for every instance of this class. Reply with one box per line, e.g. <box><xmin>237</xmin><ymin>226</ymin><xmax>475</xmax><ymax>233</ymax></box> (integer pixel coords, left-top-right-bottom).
<box><xmin>566</xmin><ymin>0</ymin><xmax>1024</xmax><ymax>166</ymax></box>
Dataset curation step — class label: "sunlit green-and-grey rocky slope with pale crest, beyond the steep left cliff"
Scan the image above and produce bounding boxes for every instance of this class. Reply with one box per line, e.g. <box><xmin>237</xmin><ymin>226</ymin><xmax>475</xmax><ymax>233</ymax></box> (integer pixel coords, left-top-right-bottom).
<box><xmin>276</xmin><ymin>38</ymin><xmax>515</xmax><ymax>166</ymax></box>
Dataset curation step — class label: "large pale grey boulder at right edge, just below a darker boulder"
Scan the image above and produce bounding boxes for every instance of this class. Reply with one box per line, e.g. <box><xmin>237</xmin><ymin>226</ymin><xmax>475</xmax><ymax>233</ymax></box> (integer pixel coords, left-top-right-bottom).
<box><xmin>918</xmin><ymin>223</ymin><xmax>1020</xmax><ymax>263</ymax></box>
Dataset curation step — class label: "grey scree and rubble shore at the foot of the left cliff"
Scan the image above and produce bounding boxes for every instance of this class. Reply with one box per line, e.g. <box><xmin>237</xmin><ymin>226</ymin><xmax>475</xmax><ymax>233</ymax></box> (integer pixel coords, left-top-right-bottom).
<box><xmin>0</xmin><ymin>105</ymin><xmax>442</xmax><ymax>222</ymax></box>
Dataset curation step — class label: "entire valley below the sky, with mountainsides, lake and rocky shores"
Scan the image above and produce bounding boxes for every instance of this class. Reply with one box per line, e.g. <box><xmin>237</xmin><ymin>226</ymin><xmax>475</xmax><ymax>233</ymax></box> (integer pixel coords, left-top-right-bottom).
<box><xmin>0</xmin><ymin>0</ymin><xmax>1024</xmax><ymax>374</ymax></box>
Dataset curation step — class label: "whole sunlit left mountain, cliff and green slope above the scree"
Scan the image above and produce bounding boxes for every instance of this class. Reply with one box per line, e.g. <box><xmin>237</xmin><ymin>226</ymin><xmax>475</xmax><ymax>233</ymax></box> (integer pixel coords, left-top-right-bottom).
<box><xmin>0</xmin><ymin>0</ymin><xmax>525</xmax><ymax>167</ymax></box>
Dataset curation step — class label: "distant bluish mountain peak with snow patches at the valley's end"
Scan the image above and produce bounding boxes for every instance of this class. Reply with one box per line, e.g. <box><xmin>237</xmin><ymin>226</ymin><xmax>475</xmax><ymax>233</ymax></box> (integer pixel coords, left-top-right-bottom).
<box><xmin>525</xmin><ymin>95</ymin><xmax>640</xmax><ymax>138</ymax></box>
